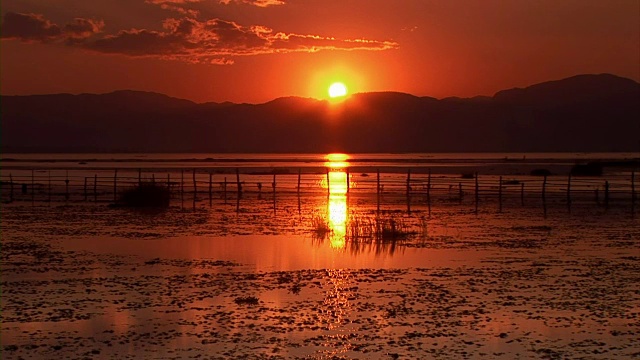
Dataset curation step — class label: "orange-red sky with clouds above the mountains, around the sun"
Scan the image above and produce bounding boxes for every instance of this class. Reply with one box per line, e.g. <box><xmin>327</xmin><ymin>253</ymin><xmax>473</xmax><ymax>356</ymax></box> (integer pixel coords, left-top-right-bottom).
<box><xmin>0</xmin><ymin>0</ymin><xmax>640</xmax><ymax>103</ymax></box>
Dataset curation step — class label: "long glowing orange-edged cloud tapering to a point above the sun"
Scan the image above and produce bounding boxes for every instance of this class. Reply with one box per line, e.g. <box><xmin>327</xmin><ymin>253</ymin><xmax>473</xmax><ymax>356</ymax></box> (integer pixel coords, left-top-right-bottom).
<box><xmin>83</xmin><ymin>18</ymin><xmax>398</xmax><ymax>64</ymax></box>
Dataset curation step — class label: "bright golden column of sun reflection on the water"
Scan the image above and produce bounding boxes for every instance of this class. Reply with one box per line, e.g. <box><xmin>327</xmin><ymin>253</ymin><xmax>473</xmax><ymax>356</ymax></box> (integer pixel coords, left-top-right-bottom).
<box><xmin>325</xmin><ymin>154</ymin><xmax>349</xmax><ymax>249</ymax></box>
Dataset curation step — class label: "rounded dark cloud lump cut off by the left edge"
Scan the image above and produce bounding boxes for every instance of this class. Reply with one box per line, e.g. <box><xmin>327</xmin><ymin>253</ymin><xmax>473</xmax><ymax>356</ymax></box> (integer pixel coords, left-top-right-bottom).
<box><xmin>0</xmin><ymin>12</ymin><xmax>62</xmax><ymax>42</ymax></box>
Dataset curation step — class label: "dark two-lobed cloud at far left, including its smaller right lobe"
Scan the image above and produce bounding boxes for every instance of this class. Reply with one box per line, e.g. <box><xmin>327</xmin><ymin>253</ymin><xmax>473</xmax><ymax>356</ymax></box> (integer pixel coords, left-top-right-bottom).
<box><xmin>0</xmin><ymin>12</ymin><xmax>104</xmax><ymax>43</ymax></box>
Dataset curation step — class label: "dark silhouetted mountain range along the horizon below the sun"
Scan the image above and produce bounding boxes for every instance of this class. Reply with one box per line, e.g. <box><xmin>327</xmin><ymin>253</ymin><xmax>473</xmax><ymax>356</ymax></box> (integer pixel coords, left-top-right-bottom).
<box><xmin>0</xmin><ymin>74</ymin><xmax>640</xmax><ymax>152</ymax></box>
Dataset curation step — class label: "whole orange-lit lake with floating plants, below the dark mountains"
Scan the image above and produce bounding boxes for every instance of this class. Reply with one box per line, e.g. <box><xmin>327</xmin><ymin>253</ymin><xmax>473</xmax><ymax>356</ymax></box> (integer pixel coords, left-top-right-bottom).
<box><xmin>0</xmin><ymin>154</ymin><xmax>640</xmax><ymax>359</ymax></box>
